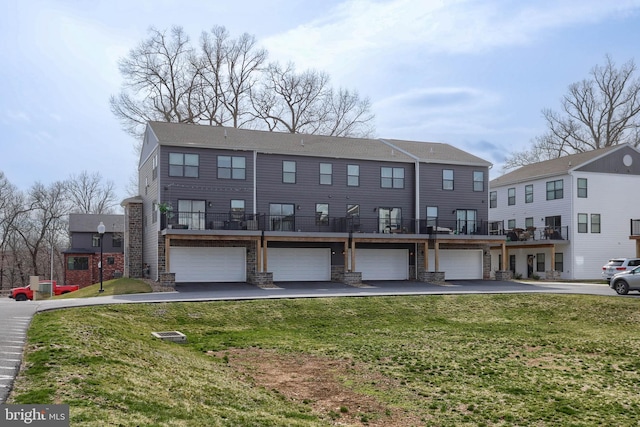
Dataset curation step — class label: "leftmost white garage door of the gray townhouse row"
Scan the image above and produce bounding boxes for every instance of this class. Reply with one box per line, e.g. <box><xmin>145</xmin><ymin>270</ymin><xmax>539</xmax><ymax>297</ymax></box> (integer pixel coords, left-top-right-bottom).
<box><xmin>169</xmin><ymin>247</ymin><xmax>247</xmax><ymax>283</ymax></box>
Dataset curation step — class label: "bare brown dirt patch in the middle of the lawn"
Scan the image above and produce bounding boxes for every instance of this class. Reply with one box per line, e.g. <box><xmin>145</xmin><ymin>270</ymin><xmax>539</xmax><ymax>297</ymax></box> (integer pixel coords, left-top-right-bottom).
<box><xmin>210</xmin><ymin>349</ymin><xmax>424</xmax><ymax>427</ymax></box>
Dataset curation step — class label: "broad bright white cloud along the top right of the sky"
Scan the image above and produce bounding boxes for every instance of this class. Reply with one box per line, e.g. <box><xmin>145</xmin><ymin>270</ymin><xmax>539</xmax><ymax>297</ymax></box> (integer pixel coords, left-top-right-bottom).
<box><xmin>264</xmin><ymin>0</ymin><xmax>640</xmax><ymax>72</ymax></box>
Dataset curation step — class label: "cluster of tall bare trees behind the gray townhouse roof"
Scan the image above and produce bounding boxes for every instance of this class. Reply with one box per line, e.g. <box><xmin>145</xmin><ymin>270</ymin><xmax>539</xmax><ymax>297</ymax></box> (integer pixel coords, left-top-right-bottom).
<box><xmin>110</xmin><ymin>26</ymin><xmax>374</xmax><ymax>138</ymax></box>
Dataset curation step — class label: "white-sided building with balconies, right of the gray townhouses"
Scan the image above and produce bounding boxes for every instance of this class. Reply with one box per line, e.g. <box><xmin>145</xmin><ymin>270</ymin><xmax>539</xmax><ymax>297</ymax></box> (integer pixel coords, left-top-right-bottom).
<box><xmin>489</xmin><ymin>144</ymin><xmax>640</xmax><ymax>279</ymax></box>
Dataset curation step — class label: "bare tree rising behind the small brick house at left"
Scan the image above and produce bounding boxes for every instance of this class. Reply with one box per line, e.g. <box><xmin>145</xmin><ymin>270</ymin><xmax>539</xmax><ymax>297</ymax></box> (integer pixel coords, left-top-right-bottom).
<box><xmin>65</xmin><ymin>171</ymin><xmax>117</xmax><ymax>214</ymax></box>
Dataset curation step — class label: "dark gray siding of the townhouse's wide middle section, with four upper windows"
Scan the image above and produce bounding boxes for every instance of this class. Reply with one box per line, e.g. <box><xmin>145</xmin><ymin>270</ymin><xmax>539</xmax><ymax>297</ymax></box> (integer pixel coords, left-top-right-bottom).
<box><xmin>257</xmin><ymin>154</ymin><xmax>415</xmax><ymax>218</ymax></box>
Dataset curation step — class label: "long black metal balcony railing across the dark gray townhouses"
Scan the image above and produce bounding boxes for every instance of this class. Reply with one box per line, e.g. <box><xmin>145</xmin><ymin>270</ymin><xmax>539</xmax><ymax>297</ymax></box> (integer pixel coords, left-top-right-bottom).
<box><xmin>160</xmin><ymin>212</ymin><xmax>489</xmax><ymax>235</ymax></box>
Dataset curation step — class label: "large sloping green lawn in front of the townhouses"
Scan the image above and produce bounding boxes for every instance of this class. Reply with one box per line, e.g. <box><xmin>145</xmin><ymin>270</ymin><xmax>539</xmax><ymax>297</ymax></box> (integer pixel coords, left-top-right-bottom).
<box><xmin>8</xmin><ymin>295</ymin><xmax>640</xmax><ymax>426</ymax></box>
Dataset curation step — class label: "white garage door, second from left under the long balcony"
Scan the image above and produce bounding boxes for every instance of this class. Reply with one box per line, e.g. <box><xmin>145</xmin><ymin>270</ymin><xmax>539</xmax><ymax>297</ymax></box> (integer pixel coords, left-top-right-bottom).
<box><xmin>267</xmin><ymin>248</ymin><xmax>331</xmax><ymax>282</ymax></box>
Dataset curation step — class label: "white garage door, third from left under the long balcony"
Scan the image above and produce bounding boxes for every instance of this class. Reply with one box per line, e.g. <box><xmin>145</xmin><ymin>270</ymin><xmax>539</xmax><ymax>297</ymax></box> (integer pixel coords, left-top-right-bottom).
<box><xmin>355</xmin><ymin>249</ymin><xmax>409</xmax><ymax>280</ymax></box>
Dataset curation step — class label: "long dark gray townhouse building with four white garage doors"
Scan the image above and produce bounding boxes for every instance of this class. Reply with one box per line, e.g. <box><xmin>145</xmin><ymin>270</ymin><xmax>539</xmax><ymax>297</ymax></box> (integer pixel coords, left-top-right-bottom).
<box><xmin>123</xmin><ymin>122</ymin><xmax>505</xmax><ymax>285</ymax></box>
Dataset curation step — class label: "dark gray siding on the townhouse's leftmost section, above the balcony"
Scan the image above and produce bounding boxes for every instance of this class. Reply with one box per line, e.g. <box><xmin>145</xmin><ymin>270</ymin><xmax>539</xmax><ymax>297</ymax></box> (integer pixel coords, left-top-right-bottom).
<box><xmin>159</xmin><ymin>146</ymin><xmax>253</xmax><ymax>214</ymax></box>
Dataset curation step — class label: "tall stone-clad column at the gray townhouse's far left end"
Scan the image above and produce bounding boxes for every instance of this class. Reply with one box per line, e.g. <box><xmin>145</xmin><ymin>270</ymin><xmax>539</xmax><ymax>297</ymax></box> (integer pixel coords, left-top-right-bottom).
<box><xmin>121</xmin><ymin>197</ymin><xmax>143</xmax><ymax>278</ymax></box>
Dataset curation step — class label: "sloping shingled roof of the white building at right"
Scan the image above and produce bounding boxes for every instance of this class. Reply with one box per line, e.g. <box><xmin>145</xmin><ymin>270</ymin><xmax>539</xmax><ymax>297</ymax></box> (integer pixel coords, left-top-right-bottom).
<box><xmin>489</xmin><ymin>144</ymin><xmax>627</xmax><ymax>187</ymax></box>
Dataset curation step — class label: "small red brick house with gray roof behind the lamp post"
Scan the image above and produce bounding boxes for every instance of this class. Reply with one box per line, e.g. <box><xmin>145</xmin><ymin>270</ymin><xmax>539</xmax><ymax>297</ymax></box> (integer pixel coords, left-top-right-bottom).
<box><xmin>63</xmin><ymin>214</ymin><xmax>124</xmax><ymax>288</ymax></box>
